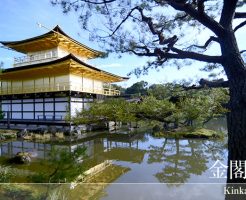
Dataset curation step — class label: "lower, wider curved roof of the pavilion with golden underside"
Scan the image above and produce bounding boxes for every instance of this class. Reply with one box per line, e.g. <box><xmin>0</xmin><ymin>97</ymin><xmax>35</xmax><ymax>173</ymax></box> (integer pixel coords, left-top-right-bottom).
<box><xmin>0</xmin><ymin>54</ymin><xmax>129</xmax><ymax>82</ymax></box>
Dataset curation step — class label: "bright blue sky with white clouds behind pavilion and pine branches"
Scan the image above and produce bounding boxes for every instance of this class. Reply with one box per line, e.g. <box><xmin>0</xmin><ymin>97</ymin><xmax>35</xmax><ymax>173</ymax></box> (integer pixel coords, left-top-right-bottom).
<box><xmin>0</xmin><ymin>0</ymin><xmax>246</xmax><ymax>87</ymax></box>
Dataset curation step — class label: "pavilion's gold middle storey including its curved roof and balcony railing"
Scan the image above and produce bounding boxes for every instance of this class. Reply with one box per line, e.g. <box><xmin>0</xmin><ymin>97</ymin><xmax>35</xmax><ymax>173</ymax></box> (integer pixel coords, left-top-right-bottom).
<box><xmin>0</xmin><ymin>54</ymin><xmax>127</xmax><ymax>96</ymax></box>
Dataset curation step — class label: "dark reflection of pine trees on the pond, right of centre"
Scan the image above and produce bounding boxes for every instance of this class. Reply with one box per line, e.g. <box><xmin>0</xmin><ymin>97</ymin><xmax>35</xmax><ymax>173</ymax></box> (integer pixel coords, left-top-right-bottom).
<box><xmin>148</xmin><ymin>139</ymin><xmax>227</xmax><ymax>183</ymax></box>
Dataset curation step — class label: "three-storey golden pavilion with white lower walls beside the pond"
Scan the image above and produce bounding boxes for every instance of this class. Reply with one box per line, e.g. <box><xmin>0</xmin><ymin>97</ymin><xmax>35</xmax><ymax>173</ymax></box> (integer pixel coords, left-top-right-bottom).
<box><xmin>0</xmin><ymin>26</ymin><xmax>127</xmax><ymax>128</ymax></box>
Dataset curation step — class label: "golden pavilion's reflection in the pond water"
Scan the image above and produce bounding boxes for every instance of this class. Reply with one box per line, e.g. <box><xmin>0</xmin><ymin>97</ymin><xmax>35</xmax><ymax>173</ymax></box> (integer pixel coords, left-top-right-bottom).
<box><xmin>0</xmin><ymin>134</ymin><xmax>145</xmax><ymax>199</ymax></box>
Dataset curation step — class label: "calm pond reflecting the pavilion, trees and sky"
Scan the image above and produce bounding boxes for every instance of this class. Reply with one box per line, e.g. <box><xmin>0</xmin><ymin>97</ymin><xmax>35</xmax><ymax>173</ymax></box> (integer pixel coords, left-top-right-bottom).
<box><xmin>0</xmin><ymin>119</ymin><xmax>227</xmax><ymax>200</ymax></box>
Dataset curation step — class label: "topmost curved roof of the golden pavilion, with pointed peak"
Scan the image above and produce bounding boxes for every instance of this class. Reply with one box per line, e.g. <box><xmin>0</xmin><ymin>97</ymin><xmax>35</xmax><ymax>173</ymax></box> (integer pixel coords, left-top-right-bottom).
<box><xmin>0</xmin><ymin>25</ymin><xmax>105</xmax><ymax>58</ymax></box>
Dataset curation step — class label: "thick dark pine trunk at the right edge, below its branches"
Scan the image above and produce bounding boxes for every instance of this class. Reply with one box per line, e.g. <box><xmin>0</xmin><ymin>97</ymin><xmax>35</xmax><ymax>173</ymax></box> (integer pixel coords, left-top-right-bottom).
<box><xmin>221</xmin><ymin>29</ymin><xmax>246</xmax><ymax>183</ymax></box>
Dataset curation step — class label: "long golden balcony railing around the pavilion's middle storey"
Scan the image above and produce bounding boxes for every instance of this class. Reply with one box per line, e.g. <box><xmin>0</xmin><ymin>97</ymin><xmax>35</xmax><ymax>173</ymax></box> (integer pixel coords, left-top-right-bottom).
<box><xmin>0</xmin><ymin>83</ymin><xmax>120</xmax><ymax>96</ymax></box>
